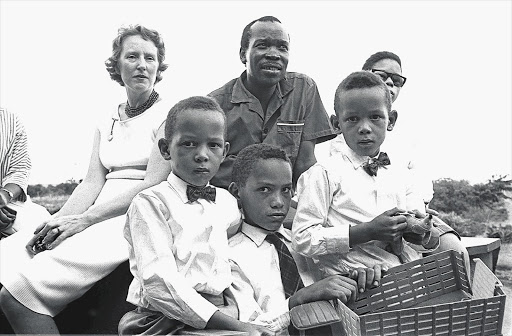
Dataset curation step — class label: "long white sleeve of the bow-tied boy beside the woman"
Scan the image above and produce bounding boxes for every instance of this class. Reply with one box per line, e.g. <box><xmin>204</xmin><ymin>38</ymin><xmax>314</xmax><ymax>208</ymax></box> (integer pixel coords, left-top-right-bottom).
<box><xmin>127</xmin><ymin>194</ymin><xmax>217</xmax><ymax>329</ymax></box>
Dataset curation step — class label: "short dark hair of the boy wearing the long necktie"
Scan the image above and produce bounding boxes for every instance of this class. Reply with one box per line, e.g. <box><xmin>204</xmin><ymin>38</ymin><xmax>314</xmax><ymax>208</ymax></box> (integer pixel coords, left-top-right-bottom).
<box><xmin>231</xmin><ymin>143</ymin><xmax>291</xmax><ymax>187</ymax></box>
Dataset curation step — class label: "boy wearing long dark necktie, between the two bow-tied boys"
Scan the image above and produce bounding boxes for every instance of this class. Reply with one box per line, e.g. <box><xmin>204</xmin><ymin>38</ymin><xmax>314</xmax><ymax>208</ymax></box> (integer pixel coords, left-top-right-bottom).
<box><xmin>227</xmin><ymin>144</ymin><xmax>381</xmax><ymax>335</ymax></box>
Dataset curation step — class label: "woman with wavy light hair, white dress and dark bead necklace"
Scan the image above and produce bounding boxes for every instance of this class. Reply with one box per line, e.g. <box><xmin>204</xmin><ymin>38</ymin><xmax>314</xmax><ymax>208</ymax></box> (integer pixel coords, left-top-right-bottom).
<box><xmin>0</xmin><ymin>25</ymin><xmax>174</xmax><ymax>334</ymax></box>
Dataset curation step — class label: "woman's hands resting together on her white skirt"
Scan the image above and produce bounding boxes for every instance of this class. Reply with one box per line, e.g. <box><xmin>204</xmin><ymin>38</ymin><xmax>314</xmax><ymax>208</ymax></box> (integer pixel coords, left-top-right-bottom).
<box><xmin>26</xmin><ymin>215</ymin><xmax>93</xmax><ymax>254</ymax></box>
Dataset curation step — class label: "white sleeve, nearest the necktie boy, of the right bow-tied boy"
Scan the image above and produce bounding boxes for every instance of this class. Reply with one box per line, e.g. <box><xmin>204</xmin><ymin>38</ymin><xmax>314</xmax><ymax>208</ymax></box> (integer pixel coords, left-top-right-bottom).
<box><xmin>292</xmin><ymin>164</ymin><xmax>349</xmax><ymax>257</ymax></box>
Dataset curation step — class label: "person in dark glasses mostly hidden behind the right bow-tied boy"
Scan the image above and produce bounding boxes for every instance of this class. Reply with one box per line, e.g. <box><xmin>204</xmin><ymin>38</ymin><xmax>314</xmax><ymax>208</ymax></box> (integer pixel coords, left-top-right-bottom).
<box><xmin>330</xmin><ymin>51</ymin><xmax>470</xmax><ymax>270</ymax></box>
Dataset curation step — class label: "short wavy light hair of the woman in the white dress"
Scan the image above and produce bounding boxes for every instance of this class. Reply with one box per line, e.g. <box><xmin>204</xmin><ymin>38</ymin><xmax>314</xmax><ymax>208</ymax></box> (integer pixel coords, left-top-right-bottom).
<box><xmin>105</xmin><ymin>25</ymin><xmax>168</xmax><ymax>86</ymax></box>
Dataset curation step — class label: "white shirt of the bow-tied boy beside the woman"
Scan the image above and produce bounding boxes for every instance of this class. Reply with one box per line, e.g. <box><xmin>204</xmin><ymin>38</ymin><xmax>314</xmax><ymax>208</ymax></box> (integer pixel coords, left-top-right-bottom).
<box><xmin>125</xmin><ymin>173</ymin><xmax>241</xmax><ymax>329</ymax></box>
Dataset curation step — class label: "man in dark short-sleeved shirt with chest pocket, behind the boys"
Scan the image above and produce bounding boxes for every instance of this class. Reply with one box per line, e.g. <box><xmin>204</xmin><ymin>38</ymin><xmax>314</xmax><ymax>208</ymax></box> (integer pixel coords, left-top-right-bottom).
<box><xmin>209</xmin><ymin>16</ymin><xmax>336</xmax><ymax>188</ymax></box>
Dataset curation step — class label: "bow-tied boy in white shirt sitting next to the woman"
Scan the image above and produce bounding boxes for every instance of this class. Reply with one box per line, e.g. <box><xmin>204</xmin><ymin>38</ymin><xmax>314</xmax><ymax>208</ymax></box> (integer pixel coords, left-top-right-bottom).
<box><xmin>119</xmin><ymin>97</ymin><xmax>267</xmax><ymax>335</ymax></box>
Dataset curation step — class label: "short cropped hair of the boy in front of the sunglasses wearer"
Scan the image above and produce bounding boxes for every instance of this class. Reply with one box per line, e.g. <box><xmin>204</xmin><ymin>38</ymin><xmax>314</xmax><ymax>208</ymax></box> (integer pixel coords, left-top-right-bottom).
<box><xmin>334</xmin><ymin>71</ymin><xmax>391</xmax><ymax>116</ymax></box>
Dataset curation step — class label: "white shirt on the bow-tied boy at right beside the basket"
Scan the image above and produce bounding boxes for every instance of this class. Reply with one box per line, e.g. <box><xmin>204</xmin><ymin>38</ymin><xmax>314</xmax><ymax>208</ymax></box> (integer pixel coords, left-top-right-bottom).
<box><xmin>292</xmin><ymin>145</ymin><xmax>425</xmax><ymax>275</ymax></box>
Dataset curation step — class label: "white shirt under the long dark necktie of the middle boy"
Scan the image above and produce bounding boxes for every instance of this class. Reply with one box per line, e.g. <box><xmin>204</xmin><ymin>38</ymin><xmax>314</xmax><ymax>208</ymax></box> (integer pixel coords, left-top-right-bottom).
<box><xmin>226</xmin><ymin>223</ymin><xmax>313</xmax><ymax>335</ymax></box>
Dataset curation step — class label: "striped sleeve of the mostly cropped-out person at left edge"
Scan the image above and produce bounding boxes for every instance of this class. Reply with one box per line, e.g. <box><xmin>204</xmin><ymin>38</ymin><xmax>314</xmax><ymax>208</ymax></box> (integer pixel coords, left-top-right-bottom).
<box><xmin>2</xmin><ymin>117</ymin><xmax>32</xmax><ymax>202</ymax></box>
